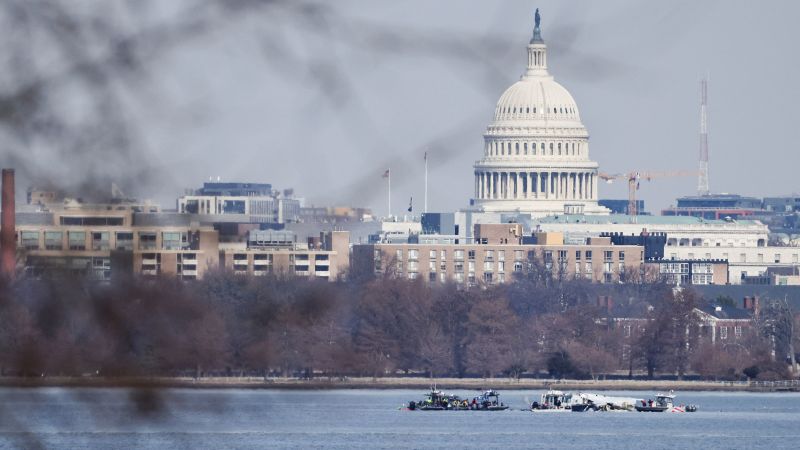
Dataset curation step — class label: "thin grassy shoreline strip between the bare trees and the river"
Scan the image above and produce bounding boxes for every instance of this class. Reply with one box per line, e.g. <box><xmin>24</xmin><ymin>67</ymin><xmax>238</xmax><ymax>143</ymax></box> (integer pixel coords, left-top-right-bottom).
<box><xmin>0</xmin><ymin>377</ymin><xmax>800</xmax><ymax>392</ymax></box>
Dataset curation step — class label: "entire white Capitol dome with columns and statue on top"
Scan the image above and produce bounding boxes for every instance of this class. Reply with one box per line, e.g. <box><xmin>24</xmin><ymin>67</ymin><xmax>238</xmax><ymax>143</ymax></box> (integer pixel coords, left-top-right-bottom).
<box><xmin>472</xmin><ymin>9</ymin><xmax>609</xmax><ymax>217</ymax></box>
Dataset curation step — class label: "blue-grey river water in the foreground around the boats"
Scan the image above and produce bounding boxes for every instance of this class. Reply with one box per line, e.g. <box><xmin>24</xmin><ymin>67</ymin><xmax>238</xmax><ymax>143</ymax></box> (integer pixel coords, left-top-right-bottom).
<box><xmin>0</xmin><ymin>388</ymin><xmax>800</xmax><ymax>449</ymax></box>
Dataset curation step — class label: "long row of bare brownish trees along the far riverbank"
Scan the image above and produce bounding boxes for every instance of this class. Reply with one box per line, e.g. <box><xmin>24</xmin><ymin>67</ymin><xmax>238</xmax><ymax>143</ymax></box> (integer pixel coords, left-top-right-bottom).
<box><xmin>0</xmin><ymin>273</ymin><xmax>794</xmax><ymax>379</ymax></box>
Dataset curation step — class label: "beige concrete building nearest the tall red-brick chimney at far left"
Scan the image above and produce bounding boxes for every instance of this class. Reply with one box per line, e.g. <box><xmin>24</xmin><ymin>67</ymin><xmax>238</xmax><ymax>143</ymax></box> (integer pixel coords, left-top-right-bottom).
<box><xmin>16</xmin><ymin>208</ymin><xmax>219</xmax><ymax>280</ymax></box>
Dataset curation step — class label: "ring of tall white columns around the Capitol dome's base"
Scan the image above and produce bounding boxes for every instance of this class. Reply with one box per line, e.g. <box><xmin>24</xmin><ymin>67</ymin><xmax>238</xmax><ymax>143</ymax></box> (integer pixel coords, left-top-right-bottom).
<box><xmin>475</xmin><ymin>170</ymin><xmax>597</xmax><ymax>200</ymax></box>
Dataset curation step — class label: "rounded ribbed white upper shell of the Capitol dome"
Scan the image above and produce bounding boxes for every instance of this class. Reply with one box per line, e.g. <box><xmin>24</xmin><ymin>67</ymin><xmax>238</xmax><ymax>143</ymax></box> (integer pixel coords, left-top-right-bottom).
<box><xmin>494</xmin><ymin>75</ymin><xmax>581</xmax><ymax>125</ymax></box>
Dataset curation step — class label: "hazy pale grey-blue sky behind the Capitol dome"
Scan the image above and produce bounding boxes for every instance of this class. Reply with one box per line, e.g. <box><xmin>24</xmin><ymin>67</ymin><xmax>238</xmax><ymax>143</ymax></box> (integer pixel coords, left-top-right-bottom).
<box><xmin>6</xmin><ymin>0</ymin><xmax>800</xmax><ymax>214</ymax></box>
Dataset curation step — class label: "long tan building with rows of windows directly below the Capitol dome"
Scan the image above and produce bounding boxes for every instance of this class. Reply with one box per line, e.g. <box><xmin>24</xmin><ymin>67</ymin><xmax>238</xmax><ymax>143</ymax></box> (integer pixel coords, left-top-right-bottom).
<box><xmin>353</xmin><ymin>230</ymin><xmax>644</xmax><ymax>286</ymax></box>
